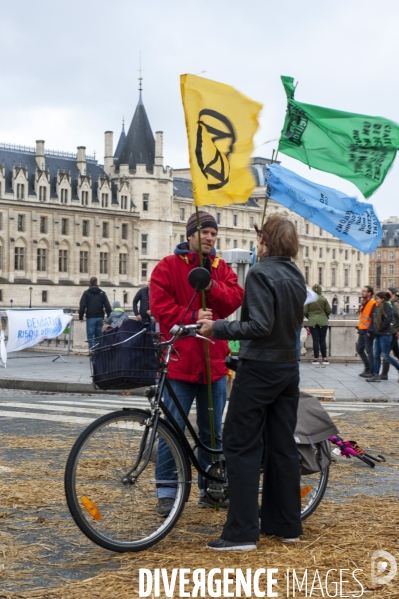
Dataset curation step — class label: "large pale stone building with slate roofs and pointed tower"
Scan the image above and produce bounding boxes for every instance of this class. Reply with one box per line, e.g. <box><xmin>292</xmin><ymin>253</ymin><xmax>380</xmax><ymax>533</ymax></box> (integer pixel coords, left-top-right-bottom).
<box><xmin>0</xmin><ymin>91</ymin><xmax>368</xmax><ymax>312</ymax></box>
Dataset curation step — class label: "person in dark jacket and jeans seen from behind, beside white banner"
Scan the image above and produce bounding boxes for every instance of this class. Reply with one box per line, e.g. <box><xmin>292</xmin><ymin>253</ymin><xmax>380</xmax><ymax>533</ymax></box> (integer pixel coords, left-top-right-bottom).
<box><xmin>79</xmin><ymin>277</ymin><xmax>112</xmax><ymax>349</ymax></box>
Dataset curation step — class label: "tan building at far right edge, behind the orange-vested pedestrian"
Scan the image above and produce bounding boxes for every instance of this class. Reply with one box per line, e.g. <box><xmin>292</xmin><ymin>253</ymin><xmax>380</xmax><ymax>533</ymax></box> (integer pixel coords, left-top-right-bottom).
<box><xmin>369</xmin><ymin>216</ymin><xmax>399</xmax><ymax>291</ymax></box>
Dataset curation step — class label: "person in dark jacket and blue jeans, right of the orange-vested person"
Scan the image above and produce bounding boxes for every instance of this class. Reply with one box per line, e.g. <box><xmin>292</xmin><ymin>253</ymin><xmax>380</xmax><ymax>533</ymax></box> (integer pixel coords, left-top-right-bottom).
<box><xmin>366</xmin><ymin>291</ymin><xmax>399</xmax><ymax>383</ymax></box>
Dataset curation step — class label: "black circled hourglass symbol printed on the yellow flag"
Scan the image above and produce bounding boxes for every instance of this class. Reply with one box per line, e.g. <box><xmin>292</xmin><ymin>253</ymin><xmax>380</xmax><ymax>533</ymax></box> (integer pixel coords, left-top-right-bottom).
<box><xmin>195</xmin><ymin>108</ymin><xmax>236</xmax><ymax>191</ymax></box>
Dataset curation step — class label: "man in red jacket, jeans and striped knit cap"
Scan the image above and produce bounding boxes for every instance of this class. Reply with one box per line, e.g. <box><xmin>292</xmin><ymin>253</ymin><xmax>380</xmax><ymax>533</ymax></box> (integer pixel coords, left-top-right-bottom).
<box><xmin>150</xmin><ymin>211</ymin><xmax>244</xmax><ymax>517</ymax></box>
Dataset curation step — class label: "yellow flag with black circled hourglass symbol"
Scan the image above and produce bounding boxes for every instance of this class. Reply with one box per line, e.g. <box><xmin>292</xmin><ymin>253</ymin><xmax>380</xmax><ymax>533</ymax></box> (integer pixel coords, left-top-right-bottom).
<box><xmin>180</xmin><ymin>75</ymin><xmax>262</xmax><ymax>206</ymax></box>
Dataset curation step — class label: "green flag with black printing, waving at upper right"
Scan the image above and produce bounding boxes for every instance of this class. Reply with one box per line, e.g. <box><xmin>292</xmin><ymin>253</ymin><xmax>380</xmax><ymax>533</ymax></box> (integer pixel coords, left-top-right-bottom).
<box><xmin>278</xmin><ymin>77</ymin><xmax>399</xmax><ymax>198</ymax></box>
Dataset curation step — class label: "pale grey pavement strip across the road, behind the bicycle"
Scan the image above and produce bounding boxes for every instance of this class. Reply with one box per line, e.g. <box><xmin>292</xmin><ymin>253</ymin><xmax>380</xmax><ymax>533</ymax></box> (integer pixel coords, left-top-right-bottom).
<box><xmin>0</xmin><ymin>353</ymin><xmax>399</xmax><ymax>401</ymax></box>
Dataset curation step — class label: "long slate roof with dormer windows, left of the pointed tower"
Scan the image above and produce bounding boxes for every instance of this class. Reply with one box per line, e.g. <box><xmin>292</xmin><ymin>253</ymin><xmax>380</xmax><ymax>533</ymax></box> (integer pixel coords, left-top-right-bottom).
<box><xmin>0</xmin><ymin>144</ymin><xmax>106</xmax><ymax>202</ymax></box>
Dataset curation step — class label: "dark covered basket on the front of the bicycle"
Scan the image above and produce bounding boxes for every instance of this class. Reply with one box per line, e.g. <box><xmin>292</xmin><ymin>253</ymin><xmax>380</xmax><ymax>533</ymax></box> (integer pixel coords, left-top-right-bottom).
<box><xmin>91</xmin><ymin>320</ymin><xmax>159</xmax><ymax>389</ymax></box>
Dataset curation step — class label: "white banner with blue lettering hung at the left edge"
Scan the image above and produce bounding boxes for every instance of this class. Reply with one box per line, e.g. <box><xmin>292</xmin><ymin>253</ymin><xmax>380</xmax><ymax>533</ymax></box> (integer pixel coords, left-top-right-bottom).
<box><xmin>6</xmin><ymin>310</ymin><xmax>72</xmax><ymax>353</ymax></box>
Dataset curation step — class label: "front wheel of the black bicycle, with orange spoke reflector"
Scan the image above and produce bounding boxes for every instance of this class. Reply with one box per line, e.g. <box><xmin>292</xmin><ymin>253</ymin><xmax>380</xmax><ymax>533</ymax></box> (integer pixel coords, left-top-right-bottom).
<box><xmin>65</xmin><ymin>410</ymin><xmax>191</xmax><ymax>552</ymax></box>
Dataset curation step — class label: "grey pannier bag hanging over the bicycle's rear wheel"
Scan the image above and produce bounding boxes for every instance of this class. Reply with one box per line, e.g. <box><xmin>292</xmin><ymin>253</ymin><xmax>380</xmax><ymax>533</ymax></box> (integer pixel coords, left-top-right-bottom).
<box><xmin>295</xmin><ymin>391</ymin><xmax>338</xmax><ymax>474</ymax></box>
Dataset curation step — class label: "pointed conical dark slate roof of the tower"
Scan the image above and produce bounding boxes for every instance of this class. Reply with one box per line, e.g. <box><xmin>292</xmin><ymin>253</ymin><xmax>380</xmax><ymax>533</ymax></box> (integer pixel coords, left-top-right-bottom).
<box><xmin>115</xmin><ymin>92</ymin><xmax>155</xmax><ymax>171</ymax></box>
